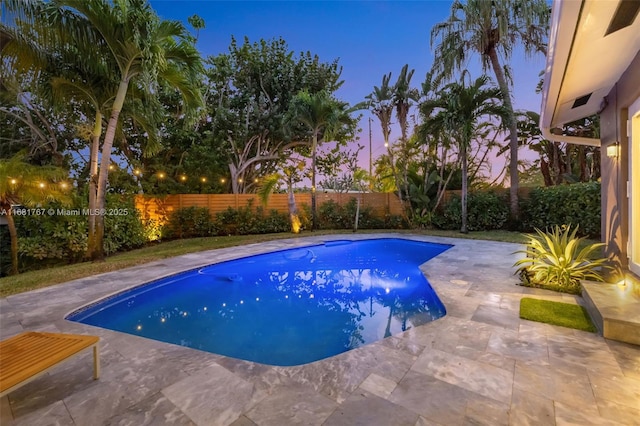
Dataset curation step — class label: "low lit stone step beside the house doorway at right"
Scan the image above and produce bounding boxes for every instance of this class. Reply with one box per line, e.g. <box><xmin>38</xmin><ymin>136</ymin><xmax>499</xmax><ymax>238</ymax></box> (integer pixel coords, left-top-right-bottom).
<box><xmin>581</xmin><ymin>281</ymin><xmax>640</xmax><ymax>345</ymax></box>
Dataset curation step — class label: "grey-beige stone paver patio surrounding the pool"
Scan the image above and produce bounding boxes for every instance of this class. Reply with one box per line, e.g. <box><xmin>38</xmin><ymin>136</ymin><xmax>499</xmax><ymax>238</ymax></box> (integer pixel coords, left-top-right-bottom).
<box><xmin>0</xmin><ymin>234</ymin><xmax>640</xmax><ymax>426</ymax></box>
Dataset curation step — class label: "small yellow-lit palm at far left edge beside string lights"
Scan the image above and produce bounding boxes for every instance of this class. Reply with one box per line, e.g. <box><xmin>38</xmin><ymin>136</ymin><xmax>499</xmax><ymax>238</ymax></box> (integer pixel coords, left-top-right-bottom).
<box><xmin>0</xmin><ymin>153</ymin><xmax>67</xmax><ymax>275</ymax></box>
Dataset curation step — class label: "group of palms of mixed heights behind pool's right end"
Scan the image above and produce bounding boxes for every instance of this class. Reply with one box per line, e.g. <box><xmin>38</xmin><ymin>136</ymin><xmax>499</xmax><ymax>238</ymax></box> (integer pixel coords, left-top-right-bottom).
<box><xmin>367</xmin><ymin>0</ymin><xmax>550</xmax><ymax>232</ymax></box>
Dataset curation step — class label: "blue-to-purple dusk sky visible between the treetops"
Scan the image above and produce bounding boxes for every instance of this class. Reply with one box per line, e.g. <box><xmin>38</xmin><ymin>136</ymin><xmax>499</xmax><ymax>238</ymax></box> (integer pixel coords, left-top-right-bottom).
<box><xmin>151</xmin><ymin>0</ymin><xmax>545</xmax><ymax>175</ymax></box>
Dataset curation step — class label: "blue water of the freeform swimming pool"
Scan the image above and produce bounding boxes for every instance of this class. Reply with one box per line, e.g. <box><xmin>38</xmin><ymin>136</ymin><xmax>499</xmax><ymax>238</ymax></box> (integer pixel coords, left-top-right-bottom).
<box><xmin>67</xmin><ymin>238</ymin><xmax>451</xmax><ymax>366</ymax></box>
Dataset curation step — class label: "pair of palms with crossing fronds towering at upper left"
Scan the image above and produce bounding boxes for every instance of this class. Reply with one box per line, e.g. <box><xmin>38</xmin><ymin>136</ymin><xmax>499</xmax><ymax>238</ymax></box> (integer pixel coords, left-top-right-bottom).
<box><xmin>2</xmin><ymin>0</ymin><xmax>202</xmax><ymax>259</ymax></box>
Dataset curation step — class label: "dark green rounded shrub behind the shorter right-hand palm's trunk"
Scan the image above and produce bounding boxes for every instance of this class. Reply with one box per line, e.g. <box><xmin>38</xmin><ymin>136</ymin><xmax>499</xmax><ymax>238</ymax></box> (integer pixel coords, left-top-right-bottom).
<box><xmin>432</xmin><ymin>192</ymin><xmax>509</xmax><ymax>231</ymax></box>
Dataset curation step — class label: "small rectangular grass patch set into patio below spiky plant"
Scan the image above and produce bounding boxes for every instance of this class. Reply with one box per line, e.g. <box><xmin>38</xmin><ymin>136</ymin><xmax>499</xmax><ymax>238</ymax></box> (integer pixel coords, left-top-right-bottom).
<box><xmin>520</xmin><ymin>297</ymin><xmax>596</xmax><ymax>332</ymax></box>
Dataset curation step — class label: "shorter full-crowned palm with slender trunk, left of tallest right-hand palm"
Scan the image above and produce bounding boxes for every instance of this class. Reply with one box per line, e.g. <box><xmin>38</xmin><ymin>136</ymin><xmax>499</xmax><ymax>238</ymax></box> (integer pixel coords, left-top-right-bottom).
<box><xmin>421</xmin><ymin>72</ymin><xmax>508</xmax><ymax>233</ymax></box>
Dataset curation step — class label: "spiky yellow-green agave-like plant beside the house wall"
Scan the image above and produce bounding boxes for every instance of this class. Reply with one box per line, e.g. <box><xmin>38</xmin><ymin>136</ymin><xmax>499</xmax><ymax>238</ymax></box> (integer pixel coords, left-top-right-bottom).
<box><xmin>513</xmin><ymin>226</ymin><xmax>609</xmax><ymax>293</ymax></box>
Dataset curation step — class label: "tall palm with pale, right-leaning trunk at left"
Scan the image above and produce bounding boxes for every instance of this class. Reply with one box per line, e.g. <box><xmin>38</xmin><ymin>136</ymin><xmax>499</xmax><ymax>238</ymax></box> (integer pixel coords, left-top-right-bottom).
<box><xmin>40</xmin><ymin>0</ymin><xmax>203</xmax><ymax>259</ymax></box>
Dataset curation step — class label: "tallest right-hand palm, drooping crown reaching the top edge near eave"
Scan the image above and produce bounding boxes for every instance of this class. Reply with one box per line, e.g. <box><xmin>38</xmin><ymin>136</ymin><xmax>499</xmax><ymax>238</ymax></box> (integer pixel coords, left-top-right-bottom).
<box><xmin>431</xmin><ymin>0</ymin><xmax>550</xmax><ymax>218</ymax></box>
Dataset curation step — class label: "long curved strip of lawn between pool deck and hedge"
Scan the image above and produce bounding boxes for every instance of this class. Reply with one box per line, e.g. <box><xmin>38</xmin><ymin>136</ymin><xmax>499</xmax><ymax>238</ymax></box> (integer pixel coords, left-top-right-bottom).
<box><xmin>0</xmin><ymin>230</ymin><xmax>525</xmax><ymax>297</ymax></box>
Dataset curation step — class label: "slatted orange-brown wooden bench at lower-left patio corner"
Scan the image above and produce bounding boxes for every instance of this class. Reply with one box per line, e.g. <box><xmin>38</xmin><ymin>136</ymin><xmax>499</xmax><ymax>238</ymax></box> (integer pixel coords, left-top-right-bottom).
<box><xmin>0</xmin><ymin>331</ymin><xmax>100</xmax><ymax>397</ymax></box>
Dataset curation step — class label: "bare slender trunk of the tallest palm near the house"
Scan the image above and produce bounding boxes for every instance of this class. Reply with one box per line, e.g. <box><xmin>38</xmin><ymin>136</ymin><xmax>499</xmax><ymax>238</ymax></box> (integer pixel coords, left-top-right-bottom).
<box><xmin>489</xmin><ymin>48</ymin><xmax>520</xmax><ymax>220</ymax></box>
